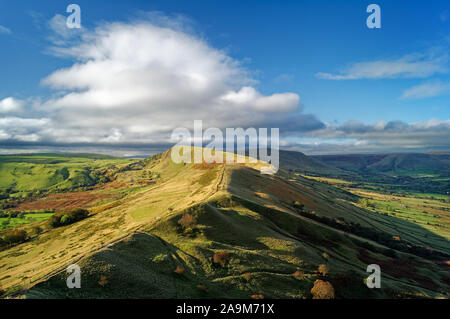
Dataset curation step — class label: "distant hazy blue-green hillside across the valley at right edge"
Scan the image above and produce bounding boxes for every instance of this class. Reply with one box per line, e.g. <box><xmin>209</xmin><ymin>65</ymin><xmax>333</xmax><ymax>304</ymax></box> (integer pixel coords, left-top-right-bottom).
<box><xmin>310</xmin><ymin>153</ymin><xmax>450</xmax><ymax>195</ymax></box>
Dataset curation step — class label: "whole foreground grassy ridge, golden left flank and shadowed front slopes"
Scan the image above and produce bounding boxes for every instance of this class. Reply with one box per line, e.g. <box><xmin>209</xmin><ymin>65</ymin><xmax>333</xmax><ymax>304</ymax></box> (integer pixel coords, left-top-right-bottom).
<box><xmin>0</xmin><ymin>152</ymin><xmax>449</xmax><ymax>298</ymax></box>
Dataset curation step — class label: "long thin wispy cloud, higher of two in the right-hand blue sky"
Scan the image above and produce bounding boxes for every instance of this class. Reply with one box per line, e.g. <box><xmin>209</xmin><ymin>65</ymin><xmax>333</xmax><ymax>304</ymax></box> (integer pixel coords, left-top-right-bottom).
<box><xmin>316</xmin><ymin>53</ymin><xmax>448</xmax><ymax>80</ymax></box>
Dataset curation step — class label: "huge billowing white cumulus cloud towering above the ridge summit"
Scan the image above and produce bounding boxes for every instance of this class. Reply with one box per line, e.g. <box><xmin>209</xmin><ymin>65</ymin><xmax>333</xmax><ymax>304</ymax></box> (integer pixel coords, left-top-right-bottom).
<box><xmin>34</xmin><ymin>21</ymin><xmax>300</xmax><ymax>143</ymax></box>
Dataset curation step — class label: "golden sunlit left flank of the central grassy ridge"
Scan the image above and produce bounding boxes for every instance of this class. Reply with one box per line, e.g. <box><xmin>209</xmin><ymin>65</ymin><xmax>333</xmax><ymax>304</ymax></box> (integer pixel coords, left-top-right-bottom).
<box><xmin>0</xmin><ymin>149</ymin><xmax>229</xmax><ymax>296</ymax></box>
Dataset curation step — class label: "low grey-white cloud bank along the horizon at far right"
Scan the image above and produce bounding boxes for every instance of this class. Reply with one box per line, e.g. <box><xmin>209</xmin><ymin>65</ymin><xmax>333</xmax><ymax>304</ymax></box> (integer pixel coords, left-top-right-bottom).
<box><xmin>280</xmin><ymin>119</ymin><xmax>450</xmax><ymax>154</ymax></box>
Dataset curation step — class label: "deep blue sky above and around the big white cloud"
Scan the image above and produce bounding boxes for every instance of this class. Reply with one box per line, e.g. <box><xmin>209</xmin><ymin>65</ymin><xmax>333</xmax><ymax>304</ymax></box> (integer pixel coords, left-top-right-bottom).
<box><xmin>0</xmin><ymin>0</ymin><xmax>450</xmax><ymax>153</ymax></box>
